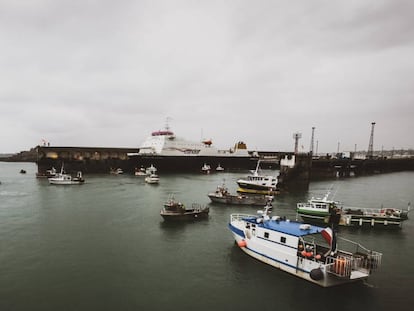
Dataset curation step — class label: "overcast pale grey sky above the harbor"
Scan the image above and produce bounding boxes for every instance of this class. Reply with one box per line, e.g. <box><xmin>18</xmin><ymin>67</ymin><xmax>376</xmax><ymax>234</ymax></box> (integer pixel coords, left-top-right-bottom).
<box><xmin>0</xmin><ymin>0</ymin><xmax>414</xmax><ymax>153</ymax></box>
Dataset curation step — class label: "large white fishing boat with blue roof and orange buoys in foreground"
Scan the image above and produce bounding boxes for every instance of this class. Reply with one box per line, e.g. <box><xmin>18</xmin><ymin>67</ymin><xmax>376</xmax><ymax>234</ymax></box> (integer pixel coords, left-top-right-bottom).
<box><xmin>229</xmin><ymin>203</ymin><xmax>382</xmax><ymax>287</ymax></box>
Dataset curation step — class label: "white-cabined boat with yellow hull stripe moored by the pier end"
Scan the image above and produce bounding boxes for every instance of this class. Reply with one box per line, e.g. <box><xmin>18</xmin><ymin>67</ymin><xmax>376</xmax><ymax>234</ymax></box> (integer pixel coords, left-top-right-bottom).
<box><xmin>237</xmin><ymin>161</ymin><xmax>277</xmax><ymax>194</ymax></box>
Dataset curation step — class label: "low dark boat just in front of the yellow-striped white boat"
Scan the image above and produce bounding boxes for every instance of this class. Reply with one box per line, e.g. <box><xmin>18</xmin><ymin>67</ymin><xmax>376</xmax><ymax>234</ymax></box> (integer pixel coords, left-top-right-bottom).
<box><xmin>207</xmin><ymin>182</ymin><xmax>273</xmax><ymax>206</ymax></box>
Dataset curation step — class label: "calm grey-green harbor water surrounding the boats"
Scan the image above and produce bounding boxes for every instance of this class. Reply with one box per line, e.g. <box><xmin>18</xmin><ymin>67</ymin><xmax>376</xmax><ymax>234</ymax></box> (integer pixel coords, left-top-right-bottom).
<box><xmin>0</xmin><ymin>162</ymin><xmax>414</xmax><ymax>311</ymax></box>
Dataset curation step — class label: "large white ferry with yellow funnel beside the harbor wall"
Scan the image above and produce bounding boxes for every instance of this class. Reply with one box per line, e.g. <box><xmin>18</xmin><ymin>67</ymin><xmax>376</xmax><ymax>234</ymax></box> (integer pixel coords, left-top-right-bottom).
<box><xmin>128</xmin><ymin>127</ymin><xmax>258</xmax><ymax>172</ymax></box>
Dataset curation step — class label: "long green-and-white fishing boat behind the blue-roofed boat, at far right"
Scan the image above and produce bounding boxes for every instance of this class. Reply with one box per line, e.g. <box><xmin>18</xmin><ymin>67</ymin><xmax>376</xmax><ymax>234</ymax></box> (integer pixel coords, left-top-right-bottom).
<box><xmin>296</xmin><ymin>192</ymin><xmax>410</xmax><ymax>228</ymax></box>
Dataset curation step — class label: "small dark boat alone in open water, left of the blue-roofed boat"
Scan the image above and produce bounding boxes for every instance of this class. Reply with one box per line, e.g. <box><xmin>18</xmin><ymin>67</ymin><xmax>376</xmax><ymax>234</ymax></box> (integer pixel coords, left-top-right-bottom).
<box><xmin>160</xmin><ymin>196</ymin><xmax>210</xmax><ymax>220</ymax></box>
